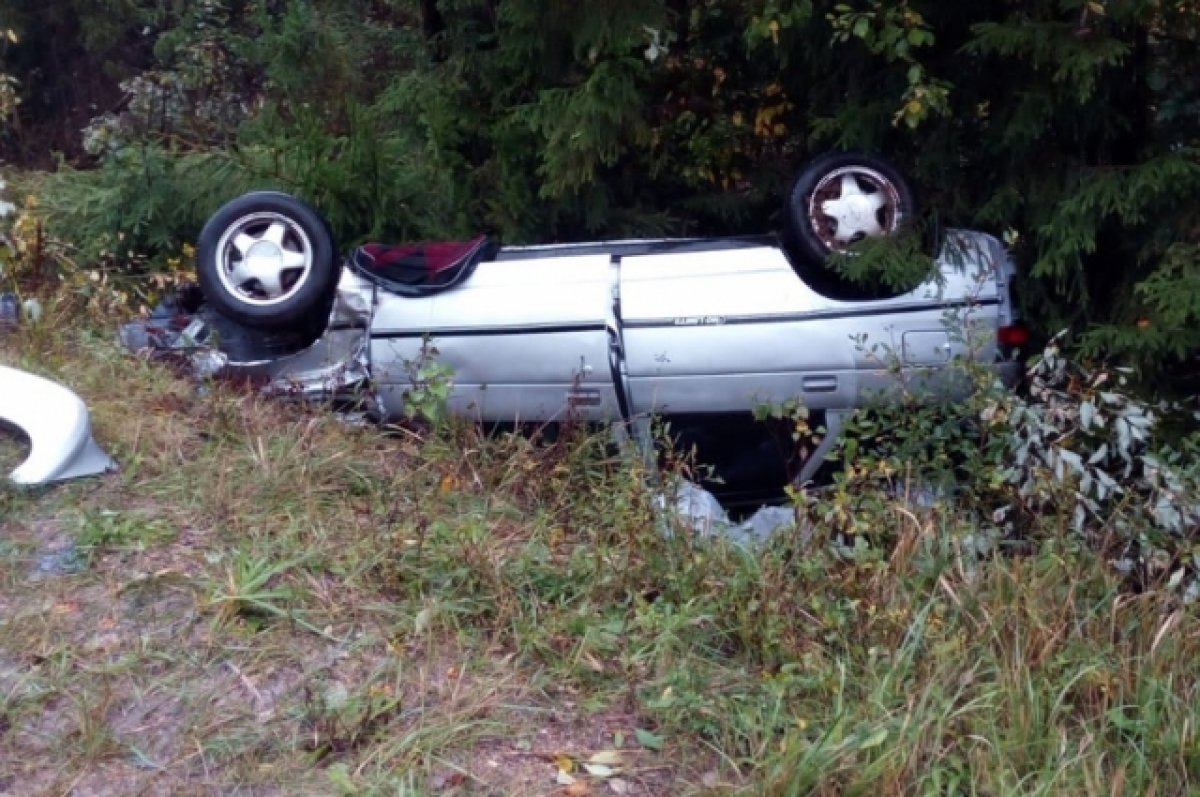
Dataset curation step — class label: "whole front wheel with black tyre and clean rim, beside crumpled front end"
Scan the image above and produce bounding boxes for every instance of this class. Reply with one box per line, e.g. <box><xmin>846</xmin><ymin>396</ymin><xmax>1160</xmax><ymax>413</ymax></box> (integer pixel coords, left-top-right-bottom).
<box><xmin>197</xmin><ymin>191</ymin><xmax>338</xmax><ymax>330</ymax></box>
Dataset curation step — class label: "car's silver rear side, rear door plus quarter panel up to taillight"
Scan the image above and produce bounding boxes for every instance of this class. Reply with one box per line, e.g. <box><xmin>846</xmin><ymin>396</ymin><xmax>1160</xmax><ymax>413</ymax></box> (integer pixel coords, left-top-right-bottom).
<box><xmin>620</xmin><ymin>236</ymin><xmax>1002</xmax><ymax>414</ymax></box>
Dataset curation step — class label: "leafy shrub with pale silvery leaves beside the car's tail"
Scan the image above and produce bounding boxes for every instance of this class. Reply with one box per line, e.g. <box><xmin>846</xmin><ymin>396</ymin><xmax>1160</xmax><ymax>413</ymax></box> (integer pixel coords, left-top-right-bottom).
<box><xmin>804</xmin><ymin>317</ymin><xmax>1200</xmax><ymax>599</ymax></box>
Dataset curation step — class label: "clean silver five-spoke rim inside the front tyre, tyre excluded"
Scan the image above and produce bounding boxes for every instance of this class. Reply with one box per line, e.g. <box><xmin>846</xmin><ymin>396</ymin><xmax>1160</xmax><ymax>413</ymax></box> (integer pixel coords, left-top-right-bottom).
<box><xmin>216</xmin><ymin>211</ymin><xmax>313</xmax><ymax>307</ymax></box>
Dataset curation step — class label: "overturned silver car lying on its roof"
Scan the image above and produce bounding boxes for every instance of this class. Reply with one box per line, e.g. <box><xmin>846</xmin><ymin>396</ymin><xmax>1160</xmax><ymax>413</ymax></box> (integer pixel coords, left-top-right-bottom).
<box><xmin>166</xmin><ymin>154</ymin><xmax>1024</xmax><ymax>492</ymax></box>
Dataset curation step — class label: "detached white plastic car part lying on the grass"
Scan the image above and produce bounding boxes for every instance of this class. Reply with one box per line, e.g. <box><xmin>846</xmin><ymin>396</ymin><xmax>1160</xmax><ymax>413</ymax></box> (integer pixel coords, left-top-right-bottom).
<box><xmin>0</xmin><ymin>366</ymin><xmax>116</xmax><ymax>485</ymax></box>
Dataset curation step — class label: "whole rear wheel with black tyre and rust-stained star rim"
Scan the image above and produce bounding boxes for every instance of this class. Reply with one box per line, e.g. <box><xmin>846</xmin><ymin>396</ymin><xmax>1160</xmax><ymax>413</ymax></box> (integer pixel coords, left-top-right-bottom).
<box><xmin>785</xmin><ymin>152</ymin><xmax>917</xmax><ymax>264</ymax></box>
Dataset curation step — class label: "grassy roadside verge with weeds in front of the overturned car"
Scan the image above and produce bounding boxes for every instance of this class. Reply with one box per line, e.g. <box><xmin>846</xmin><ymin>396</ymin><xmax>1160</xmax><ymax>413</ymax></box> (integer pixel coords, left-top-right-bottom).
<box><xmin>0</xmin><ymin>307</ymin><xmax>1200</xmax><ymax>797</ymax></box>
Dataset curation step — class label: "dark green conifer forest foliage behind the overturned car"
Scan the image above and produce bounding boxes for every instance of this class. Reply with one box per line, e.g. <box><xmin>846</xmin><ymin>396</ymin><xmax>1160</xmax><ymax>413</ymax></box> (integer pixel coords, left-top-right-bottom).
<box><xmin>0</xmin><ymin>0</ymin><xmax>1200</xmax><ymax>386</ymax></box>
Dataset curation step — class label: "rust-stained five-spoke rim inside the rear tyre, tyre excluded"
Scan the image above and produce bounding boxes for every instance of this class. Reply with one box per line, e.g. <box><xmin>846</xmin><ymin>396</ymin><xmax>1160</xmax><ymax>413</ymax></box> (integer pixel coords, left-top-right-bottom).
<box><xmin>808</xmin><ymin>166</ymin><xmax>902</xmax><ymax>251</ymax></box>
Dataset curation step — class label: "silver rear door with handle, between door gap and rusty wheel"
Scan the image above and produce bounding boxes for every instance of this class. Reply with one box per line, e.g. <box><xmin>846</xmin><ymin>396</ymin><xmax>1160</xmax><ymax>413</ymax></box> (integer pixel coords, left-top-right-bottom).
<box><xmin>620</xmin><ymin>244</ymin><xmax>857</xmax><ymax>414</ymax></box>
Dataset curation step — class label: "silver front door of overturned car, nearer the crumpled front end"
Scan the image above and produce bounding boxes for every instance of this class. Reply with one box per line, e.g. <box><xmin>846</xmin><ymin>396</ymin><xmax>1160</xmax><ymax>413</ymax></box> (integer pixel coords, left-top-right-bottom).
<box><xmin>371</xmin><ymin>250</ymin><xmax>622</xmax><ymax>421</ymax></box>
